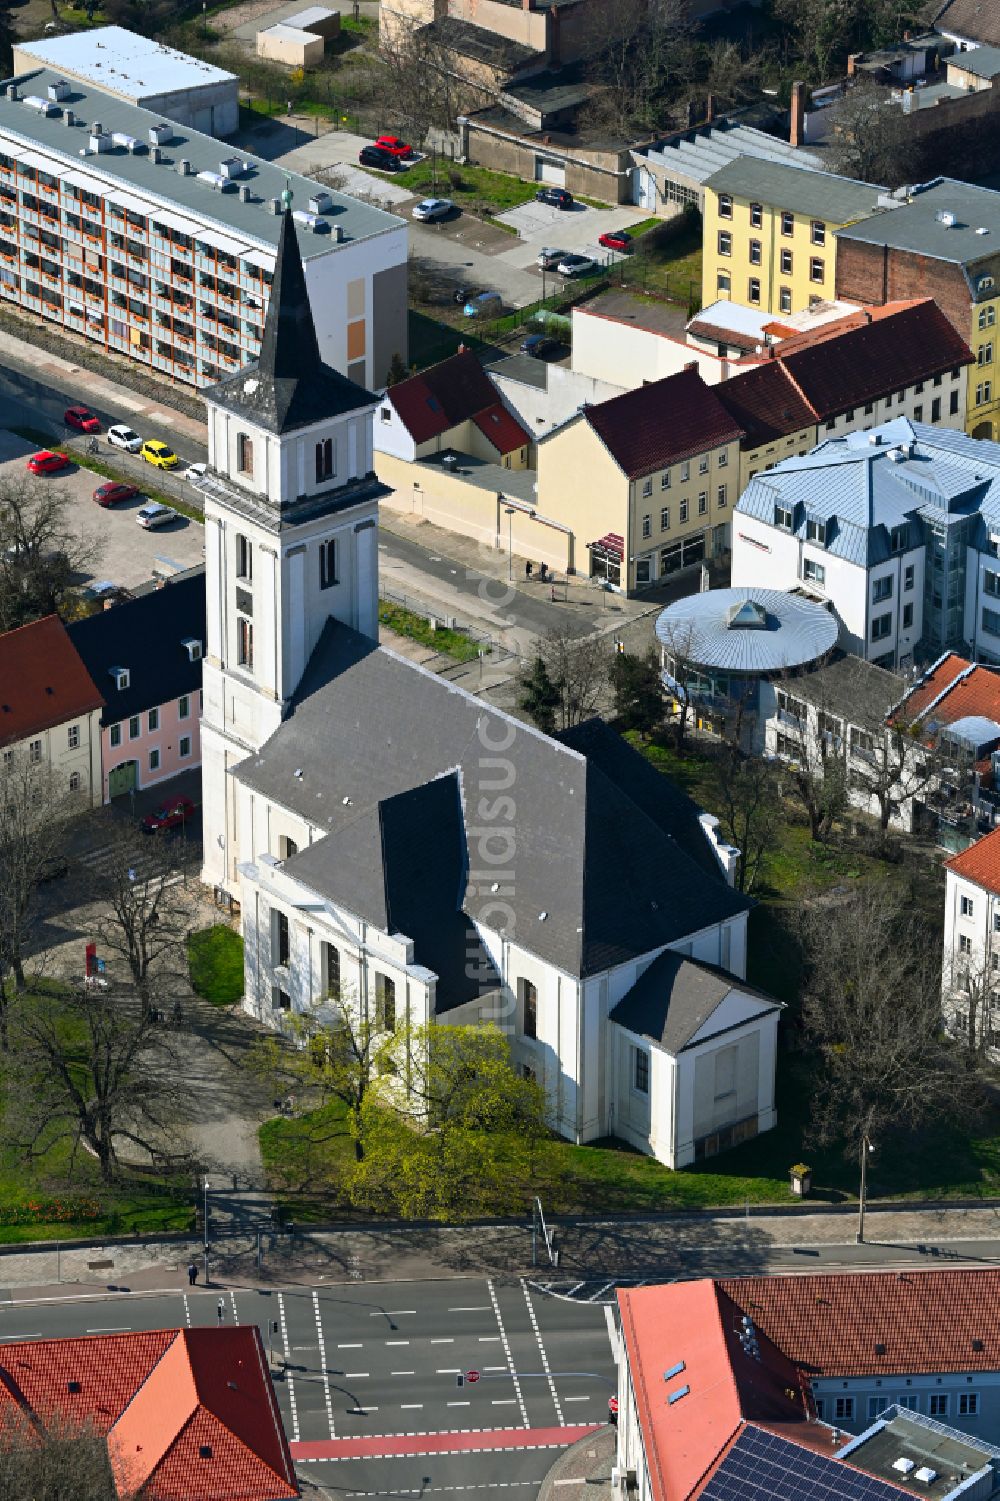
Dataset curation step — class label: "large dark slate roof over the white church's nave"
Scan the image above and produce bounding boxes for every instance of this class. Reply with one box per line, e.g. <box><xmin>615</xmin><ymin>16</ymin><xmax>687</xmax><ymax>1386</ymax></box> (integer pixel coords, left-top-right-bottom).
<box><xmin>236</xmin><ymin>621</ymin><xmax>751</xmax><ymax>984</ymax></box>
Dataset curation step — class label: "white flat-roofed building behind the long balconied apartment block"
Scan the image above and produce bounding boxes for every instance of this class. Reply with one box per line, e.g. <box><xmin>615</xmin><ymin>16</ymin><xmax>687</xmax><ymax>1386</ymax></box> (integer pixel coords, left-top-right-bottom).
<box><xmin>14</xmin><ymin>26</ymin><xmax>240</xmax><ymax>135</ymax></box>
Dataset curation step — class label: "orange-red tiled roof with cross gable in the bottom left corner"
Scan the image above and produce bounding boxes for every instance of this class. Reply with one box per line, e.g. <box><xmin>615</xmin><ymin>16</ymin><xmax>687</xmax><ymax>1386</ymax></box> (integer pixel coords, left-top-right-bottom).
<box><xmin>0</xmin><ymin>1325</ymin><xmax>299</xmax><ymax>1501</ymax></box>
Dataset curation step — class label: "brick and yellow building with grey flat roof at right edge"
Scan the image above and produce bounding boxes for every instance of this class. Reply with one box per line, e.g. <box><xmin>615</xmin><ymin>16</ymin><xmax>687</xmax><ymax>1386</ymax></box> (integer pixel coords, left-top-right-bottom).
<box><xmin>835</xmin><ymin>177</ymin><xmax>1000</xmax><ymax>440</ymax></box>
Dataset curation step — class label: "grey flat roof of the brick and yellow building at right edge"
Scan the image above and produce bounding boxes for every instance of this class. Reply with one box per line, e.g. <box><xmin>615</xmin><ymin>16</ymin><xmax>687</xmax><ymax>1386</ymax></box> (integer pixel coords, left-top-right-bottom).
<box><xmin>836</xmin><ymin>176</ymin><xmax>1000</xmax><ymax>266</ymax></box>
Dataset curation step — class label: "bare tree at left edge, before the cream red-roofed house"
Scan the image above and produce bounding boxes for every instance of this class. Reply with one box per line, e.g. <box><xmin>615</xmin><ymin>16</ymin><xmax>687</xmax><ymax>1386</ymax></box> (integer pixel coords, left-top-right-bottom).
<box><xmin>0</xmin><ymin>747</ymin><xmax>81</xmax><ymax>1014</ymax></box>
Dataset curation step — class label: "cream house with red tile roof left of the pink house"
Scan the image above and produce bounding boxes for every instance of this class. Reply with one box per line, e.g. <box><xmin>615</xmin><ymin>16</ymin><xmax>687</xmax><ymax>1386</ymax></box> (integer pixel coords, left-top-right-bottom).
<box><xmin>0</xmin><ymin>615</ymin><xmax>104</xmax><ymax>808</ymax></box>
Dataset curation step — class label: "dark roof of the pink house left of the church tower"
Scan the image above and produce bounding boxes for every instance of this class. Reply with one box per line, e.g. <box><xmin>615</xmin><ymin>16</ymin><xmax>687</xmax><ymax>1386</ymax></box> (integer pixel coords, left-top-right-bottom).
<box><xmin>66</xmin><ymin>567</ymin><xmax>206</xmax><ymax>725</ymax></box>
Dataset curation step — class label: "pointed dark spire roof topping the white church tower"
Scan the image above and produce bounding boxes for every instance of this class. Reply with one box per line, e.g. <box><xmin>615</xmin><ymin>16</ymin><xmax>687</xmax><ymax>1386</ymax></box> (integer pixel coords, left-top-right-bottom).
<box><xmin>203</xmin><ymin>209</ymin><xmax>375</xmax><ymax>432</ymax></box>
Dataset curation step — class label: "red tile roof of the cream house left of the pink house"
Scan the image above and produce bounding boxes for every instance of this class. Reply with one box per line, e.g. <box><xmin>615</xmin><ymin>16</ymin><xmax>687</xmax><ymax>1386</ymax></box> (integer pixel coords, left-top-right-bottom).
<box><xmin>0</xmin><ymin>615</ymin><xmax>104</xmax><ymax>744</ymax></box>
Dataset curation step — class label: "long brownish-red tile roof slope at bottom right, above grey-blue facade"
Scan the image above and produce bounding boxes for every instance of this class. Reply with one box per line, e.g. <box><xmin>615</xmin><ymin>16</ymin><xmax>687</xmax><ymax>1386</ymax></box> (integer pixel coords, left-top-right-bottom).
<box><xmin>720</xmin><ymin>1266</ymin><xmax>1000</xmax><ymax>1376</ymax></box>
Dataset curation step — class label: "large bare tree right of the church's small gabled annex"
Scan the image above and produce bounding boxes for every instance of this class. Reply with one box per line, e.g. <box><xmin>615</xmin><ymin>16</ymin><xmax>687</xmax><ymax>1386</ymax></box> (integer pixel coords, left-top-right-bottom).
<box><xmin>800</xmin><ymin>886</ymin><xmax>982</xmax><ymax>1153</ymax></box>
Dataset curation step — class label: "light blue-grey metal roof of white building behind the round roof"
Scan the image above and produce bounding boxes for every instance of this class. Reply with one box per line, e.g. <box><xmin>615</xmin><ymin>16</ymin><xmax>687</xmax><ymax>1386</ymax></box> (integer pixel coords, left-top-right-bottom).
<box><xmin>736</xmin><ymin>417</ymin><xmax>1000</xmax><ymax>567</ymax></box>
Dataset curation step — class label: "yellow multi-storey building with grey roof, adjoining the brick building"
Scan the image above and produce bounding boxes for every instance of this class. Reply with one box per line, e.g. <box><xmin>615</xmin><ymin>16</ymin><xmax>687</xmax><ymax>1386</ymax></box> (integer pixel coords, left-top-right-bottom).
<box><xmin>701</xmin><ymin>156</ymin><xmax>881</xmax><ymax>314</ymax></box>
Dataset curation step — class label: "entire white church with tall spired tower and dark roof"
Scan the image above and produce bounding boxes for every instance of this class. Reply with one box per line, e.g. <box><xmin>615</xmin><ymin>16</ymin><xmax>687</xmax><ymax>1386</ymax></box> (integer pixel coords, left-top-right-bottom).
<box><xmin>196</xmin><ymin>213</ymin><xmax>781</xmax><ymax>1166</ymax></box>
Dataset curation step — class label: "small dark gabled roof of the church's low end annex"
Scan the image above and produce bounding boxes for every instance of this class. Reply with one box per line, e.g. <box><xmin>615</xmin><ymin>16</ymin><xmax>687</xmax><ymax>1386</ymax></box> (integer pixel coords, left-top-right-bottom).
<box><xmin>611</xmin><ymin>949</ymin><xmax>781</xmax><ymax>1054</ymax></box>
